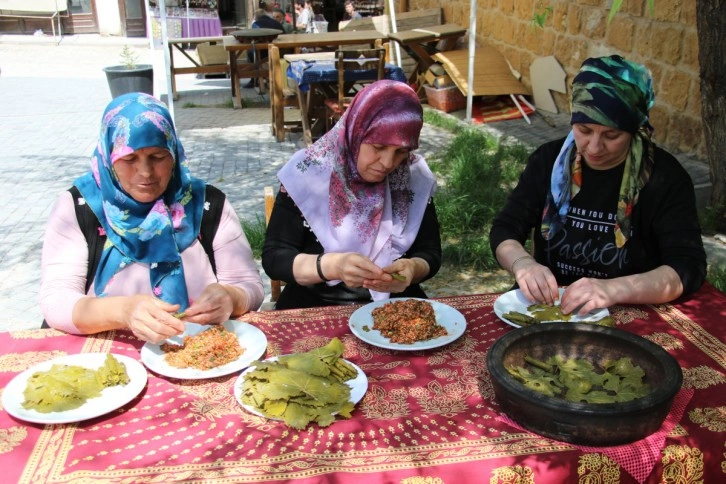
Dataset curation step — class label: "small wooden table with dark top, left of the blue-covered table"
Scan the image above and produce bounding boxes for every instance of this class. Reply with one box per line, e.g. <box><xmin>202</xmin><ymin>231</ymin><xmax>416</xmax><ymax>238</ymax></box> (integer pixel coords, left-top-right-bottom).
<box><xmin>223</xmin><ymin>29</ymin><xmax>282</xmax><ymax>109</ymax></box>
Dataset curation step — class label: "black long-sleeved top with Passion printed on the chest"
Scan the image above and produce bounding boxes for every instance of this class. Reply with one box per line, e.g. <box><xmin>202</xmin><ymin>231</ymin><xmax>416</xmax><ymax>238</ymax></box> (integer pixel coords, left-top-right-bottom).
<box><xmin>489</xmin><ymin>139</ymin><xmax>706</xmax><ymax>295</ymax></box>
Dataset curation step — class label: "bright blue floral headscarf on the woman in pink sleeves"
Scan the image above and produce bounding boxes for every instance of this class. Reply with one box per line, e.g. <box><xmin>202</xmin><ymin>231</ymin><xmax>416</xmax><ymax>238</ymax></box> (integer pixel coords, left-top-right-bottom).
<box><xmin>74</xmin><ymin>93</ymin><xmax>205</xmax><ymax>310</ymax></box>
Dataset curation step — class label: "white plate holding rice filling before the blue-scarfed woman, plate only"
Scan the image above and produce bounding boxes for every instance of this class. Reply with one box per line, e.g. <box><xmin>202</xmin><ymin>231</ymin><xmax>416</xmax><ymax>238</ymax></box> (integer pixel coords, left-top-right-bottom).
<box><xmin>141</xmin><ymin>320</ymin><xmax>267</xmax><ymax>380</ymax></box>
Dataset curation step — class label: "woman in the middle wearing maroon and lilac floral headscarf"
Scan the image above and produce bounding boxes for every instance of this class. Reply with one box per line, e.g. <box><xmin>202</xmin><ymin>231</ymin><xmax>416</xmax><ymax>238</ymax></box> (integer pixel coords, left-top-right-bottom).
<box><xmin>262</xmin><ymin>80</ymin><xmax>441</xmax><ymax>309</ymax></box>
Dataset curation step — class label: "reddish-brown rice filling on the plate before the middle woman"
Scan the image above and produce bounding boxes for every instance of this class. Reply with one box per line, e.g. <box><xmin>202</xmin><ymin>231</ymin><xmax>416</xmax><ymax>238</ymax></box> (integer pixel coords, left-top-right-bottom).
<box><xmin>372</xmin><ymin>299</ymin><xmax>448</xmax><ymax>344</ymax></box>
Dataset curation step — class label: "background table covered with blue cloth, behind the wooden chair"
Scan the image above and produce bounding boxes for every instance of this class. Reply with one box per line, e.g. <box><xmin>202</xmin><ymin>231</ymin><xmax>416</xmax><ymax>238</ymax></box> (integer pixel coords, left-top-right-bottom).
<box><xmin>284</xmin><ymin>53</ymin><xmax>406</xmax><ymax>145</ymax></box>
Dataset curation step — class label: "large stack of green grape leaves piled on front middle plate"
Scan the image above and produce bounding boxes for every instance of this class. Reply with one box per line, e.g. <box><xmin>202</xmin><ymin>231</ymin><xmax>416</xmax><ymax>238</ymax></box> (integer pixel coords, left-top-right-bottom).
<box><xmin>241</xmin><ymin>338</ymin><xmax>358</xmax><ymax>430</ymax></box>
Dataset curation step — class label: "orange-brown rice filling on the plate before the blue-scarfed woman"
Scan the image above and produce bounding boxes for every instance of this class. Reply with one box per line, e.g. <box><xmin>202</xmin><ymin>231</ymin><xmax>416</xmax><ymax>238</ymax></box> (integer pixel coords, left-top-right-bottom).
<box><xmin>161</xmin><ymin>324</ymin><xmax>245</xmax><ymax>370</ymax></box>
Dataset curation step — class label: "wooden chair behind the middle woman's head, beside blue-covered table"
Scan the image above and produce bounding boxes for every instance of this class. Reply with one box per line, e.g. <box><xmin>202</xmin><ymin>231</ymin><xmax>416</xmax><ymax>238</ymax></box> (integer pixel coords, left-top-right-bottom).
<box><xmin>325</xmin><ymin>47</ymin><xmax>386</xmax><ymax>131</ymax></box>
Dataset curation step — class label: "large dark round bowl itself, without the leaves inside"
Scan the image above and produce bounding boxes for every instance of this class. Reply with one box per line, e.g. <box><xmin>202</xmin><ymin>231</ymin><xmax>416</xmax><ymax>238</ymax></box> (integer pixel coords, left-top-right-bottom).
<box><xmin>487</xmin><ymin>322</ymin><xmax>683</xmax><ymax>446</ymax></box>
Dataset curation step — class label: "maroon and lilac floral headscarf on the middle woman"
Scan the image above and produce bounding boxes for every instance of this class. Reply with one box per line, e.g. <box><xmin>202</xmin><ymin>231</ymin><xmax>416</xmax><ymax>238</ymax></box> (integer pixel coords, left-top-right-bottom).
<box><xmin>278</xmin><ymin>80</ymin><xmax>436</xmax><ymax>299</ymax></box>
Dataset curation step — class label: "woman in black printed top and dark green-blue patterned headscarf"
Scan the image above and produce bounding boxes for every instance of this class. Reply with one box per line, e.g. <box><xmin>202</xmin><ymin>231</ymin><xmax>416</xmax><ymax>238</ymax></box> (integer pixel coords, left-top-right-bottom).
<box><xmin>490</xmin><ymin>55</ymin><xmax>706</xmax><ymax>314</ymax></box>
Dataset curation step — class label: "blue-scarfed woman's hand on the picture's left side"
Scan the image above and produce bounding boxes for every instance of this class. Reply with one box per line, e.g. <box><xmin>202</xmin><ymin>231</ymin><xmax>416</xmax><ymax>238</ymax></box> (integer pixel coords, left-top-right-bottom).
<box><xmin>125</xmin><ymin>295</ymin><xmax>185</xmax><ymax>344</ymax></box>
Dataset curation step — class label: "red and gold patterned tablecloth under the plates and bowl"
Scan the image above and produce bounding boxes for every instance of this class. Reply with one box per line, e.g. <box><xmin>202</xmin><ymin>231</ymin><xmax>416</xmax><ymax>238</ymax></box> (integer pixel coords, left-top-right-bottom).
<box><xmin>0</xmin><ymin>286</ymin><xmax>726</xmax><ymax>484</ymax></box>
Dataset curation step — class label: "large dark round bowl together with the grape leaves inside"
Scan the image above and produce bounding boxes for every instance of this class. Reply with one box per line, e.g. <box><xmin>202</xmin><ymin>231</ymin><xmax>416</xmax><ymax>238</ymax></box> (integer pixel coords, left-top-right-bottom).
<box><xmin>487</xmin><ymin>322</ymin><xmax>683</xmax><ymax>446</ymax></box>
